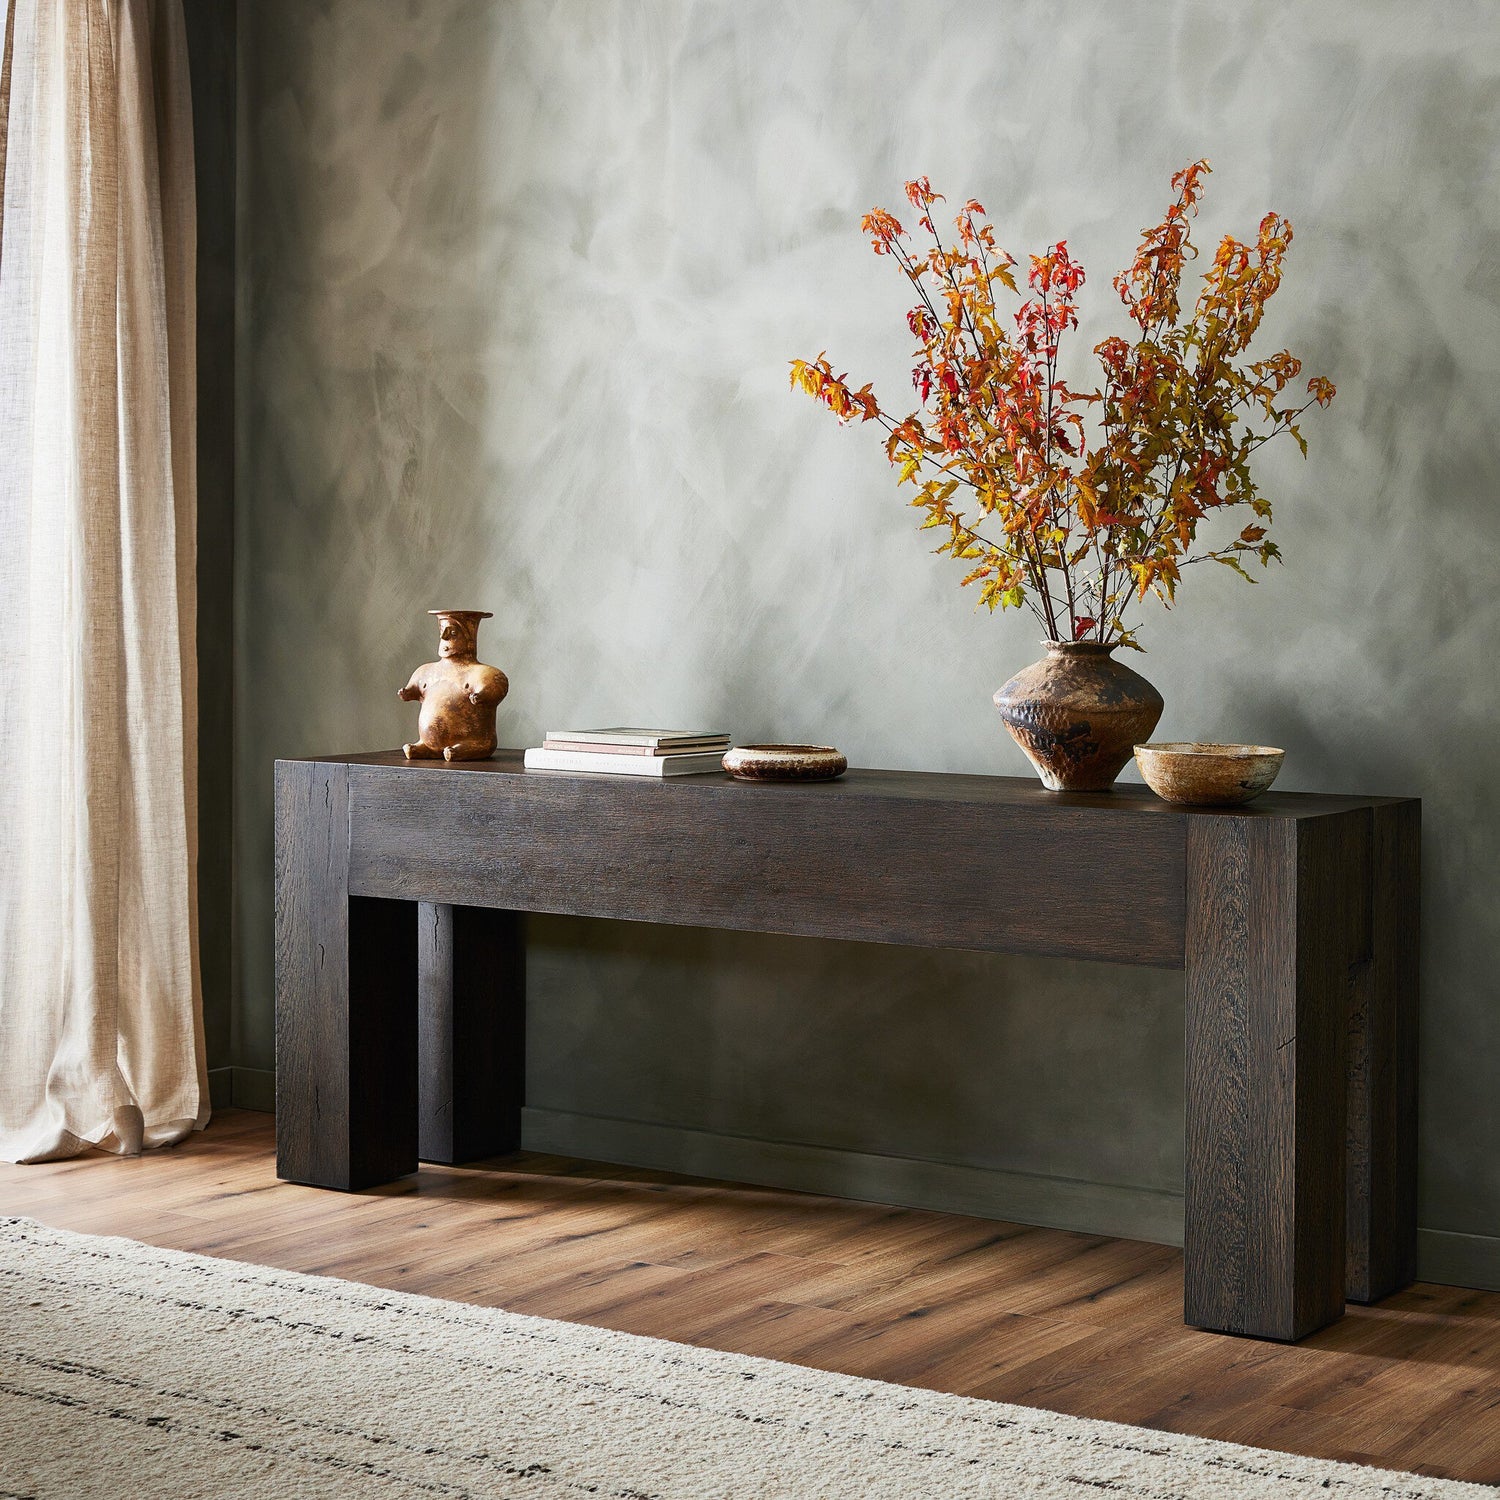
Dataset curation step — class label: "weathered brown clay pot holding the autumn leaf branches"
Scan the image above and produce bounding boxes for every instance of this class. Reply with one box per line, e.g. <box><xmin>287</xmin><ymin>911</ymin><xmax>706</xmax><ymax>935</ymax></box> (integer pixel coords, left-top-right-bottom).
<box><xmin>995</xmin><ymin>641</ymin><xmax>1163</xmax><ymax>792</ymax></box>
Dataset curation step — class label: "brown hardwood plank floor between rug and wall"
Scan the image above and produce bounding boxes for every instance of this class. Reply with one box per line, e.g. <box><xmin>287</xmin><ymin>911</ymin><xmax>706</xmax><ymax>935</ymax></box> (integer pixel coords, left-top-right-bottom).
<box><xmin>0</xmin><ymin>1110</ymin><xmax>1500</xmax><ymax>1484</ymax></box>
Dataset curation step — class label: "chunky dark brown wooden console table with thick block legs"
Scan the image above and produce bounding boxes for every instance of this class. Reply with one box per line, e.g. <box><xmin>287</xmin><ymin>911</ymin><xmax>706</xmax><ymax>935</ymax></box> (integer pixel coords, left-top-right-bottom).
<box><xmin>276</xmin><ymin>750</ymin><xmax>1421</xmax><ymax>1340</ymax></box>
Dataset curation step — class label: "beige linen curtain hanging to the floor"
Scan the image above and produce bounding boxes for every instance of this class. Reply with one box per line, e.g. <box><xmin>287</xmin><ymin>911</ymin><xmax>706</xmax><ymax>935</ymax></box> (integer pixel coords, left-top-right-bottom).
<box><xmin>0</xmin><ymin>0</ymin><xmax>207</xmax><ymax>1161</ymax></box>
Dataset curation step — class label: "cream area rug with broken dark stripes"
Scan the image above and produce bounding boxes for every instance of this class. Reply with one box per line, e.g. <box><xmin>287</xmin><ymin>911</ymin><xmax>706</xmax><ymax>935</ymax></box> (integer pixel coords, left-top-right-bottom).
<box><xmin>0</xmin><ymin>1218</ymin><xmax>1496</xmax><ymax>1500</ymax></box>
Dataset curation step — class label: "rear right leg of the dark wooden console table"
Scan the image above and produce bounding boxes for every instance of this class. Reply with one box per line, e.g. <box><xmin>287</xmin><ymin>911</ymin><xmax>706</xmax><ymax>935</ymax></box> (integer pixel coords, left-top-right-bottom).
<box><xmin>1347</xmin><ymin>803</ymin><xmax>1422</xmax><ymax>1302</ymax></box>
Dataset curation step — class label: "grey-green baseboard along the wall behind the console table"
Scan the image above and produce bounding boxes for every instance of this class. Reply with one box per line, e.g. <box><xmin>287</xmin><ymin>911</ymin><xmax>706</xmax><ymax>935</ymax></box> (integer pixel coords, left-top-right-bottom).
<box><xmin>209</xmin><ymin>1086</ymin><xmax>1500</xmax><ymax>1292</ymax></box>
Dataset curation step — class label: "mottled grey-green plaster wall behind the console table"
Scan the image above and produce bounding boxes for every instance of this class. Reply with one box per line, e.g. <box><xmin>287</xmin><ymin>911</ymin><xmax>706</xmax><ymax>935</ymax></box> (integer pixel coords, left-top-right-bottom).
<box><xmin>234</xmin><ymin>0</ymin><xmax>1500</xmax><ymax>1280</ymax></box>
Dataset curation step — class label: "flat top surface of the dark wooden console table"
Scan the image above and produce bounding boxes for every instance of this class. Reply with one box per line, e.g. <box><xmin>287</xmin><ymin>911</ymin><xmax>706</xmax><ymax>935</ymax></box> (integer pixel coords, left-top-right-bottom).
<box><xmin>288</xmin><ymin>749</ymin><xmax>1416</xmax><ymax>819</ymax></box>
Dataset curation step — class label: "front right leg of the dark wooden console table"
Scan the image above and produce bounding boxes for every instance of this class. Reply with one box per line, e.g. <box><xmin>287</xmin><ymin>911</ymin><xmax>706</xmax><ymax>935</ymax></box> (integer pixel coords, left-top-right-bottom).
<box><xmin>1184</xmin><ymin>810</ymin><xmax>1371</xmax><ymax>1340</ymax></box>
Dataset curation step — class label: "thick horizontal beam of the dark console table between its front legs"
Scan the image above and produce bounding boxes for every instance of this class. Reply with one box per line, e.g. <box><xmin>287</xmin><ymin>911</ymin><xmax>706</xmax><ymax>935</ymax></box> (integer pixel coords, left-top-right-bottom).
<box><xmin>334</xmin><ymin>762</ymin><xmax>1182</xmax><ymax>968</ymax></box>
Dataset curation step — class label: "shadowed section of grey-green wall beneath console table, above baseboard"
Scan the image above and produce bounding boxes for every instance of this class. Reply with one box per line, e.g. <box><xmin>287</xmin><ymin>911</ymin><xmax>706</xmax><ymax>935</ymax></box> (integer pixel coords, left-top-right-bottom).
<box><xmin>527</xmin><ymin>917</ymin><xmax>1184</xmax><ymax>1193</ymax></box>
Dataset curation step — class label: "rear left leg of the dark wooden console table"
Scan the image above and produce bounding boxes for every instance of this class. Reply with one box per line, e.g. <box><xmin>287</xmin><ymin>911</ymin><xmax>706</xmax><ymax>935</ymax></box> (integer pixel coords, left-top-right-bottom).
<box><xmin>417</xmin><ymin>902</ymin><xmax>527</xmax><ymax>1163</ymax></box>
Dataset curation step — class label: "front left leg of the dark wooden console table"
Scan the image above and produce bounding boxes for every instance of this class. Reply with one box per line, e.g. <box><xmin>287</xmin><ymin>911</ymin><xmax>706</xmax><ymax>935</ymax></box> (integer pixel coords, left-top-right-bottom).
<box><xmin>276</xmin><ymin>762</ymin><xmax>417</xmax><ymax>1190</ymax></box>
